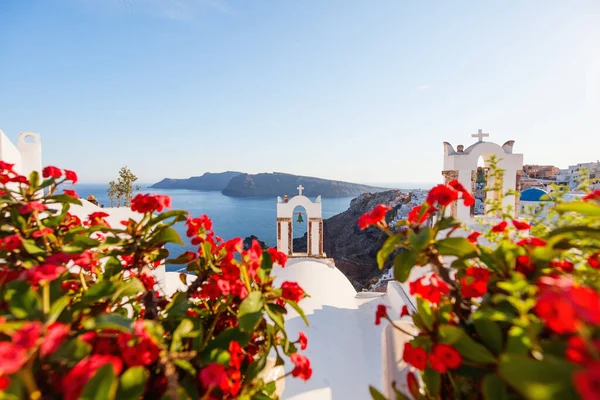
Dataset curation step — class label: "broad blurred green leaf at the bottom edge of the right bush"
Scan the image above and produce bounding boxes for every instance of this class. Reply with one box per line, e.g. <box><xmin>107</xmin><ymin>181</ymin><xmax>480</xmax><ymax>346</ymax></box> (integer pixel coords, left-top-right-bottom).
<box><xmin>498</xmin><ymin>354</ymin><xmax>579</xmax><ymax>400</ymax></box>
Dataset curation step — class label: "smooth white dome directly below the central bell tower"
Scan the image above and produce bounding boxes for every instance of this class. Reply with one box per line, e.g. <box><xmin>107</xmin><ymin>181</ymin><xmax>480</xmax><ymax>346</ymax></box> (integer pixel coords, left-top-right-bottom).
<box><xmin>273</xmin><ymin>258</ymin><xmax>358</xmax><ymax>318</ymax></box>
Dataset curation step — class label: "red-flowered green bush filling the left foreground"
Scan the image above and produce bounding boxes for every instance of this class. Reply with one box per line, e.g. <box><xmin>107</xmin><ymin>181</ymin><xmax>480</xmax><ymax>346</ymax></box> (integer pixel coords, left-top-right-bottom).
<box><xmin>0</xmin><ymin>162</ymin><xmax>312</xmax><ymax>400</ymax></box>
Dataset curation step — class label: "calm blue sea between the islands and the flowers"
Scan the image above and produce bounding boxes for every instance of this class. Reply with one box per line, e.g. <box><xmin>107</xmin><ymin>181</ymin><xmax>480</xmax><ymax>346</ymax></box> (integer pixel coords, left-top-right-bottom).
<box><xmin>69</xmin><ymin>184</ymin><xmax>353</xmax><ymax>254</ymax></box>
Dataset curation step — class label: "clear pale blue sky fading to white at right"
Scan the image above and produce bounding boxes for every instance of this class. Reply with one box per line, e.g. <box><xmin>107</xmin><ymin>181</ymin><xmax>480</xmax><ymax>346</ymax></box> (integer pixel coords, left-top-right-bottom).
<box><xmin>0</xmin><ymin>0</ymin><xmax>600</xmax><ymax>182</ymax></box>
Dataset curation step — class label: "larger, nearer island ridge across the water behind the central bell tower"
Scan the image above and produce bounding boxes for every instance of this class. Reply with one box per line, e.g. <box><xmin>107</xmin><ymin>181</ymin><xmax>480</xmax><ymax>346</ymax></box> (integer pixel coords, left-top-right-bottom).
<box><xmin>223</xmin><ymin>172</ymin><xmax>386</xmax><ymax>197</ymax></box>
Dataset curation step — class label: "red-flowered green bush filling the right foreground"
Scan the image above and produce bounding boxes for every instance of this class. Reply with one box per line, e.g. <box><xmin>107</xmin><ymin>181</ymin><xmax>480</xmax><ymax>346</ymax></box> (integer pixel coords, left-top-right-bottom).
<box><xmin>363</xmin><ymin>167</ymin><xmax>600</xmax><ymax>400</ymax></box>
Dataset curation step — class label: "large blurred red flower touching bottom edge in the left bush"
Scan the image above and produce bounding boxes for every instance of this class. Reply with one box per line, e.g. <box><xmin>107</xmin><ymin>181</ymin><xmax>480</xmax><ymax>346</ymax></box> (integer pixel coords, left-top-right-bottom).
<box><xmin>62</xmin><ymin>354</ymin><xmax>123</xmax><ymax>400</ymax></box>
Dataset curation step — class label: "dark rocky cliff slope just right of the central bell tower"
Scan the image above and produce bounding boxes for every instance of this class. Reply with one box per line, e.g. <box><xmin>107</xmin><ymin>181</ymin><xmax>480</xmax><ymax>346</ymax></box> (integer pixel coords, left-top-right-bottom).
<box><xmin>293</xmin><ymin>190</ymin><xmax>411</xmax><ymax>290</ymax></box>
